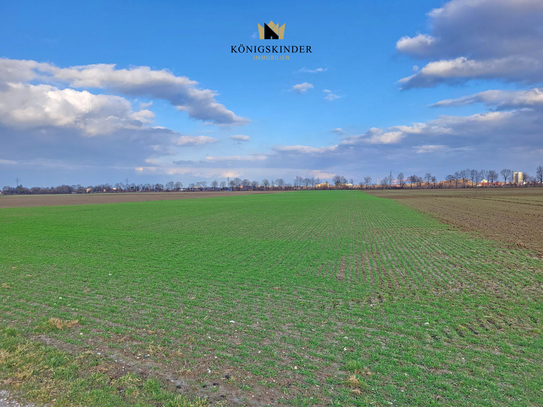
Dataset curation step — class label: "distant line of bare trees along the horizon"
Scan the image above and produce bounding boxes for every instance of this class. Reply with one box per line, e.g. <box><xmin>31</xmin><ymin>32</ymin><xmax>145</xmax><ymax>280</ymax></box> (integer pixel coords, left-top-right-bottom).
<box><xmin>2</xmin><ymin>165</ymin><xmax>543</xmax><ymax>195</ymax></box>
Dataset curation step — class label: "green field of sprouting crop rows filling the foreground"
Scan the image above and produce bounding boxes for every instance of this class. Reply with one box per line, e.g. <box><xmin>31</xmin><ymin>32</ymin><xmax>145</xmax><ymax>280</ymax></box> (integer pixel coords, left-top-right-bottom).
<box><xmin>0</xmin><ymin>191</ymin><xmax>543</xmax><ymax>406</ymax></box>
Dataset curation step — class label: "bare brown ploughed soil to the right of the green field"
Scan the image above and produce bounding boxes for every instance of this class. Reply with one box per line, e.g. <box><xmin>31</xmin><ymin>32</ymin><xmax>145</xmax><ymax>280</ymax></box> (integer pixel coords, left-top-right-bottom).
<box><xmin>367</xmin><ymin>188</ymin><xmax>543</xmax><ymax>255</ymax></box>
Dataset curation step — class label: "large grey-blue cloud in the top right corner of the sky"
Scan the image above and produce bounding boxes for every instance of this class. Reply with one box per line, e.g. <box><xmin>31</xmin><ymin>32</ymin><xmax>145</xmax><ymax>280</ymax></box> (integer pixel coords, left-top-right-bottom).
<box><xmin>396</xmin><ymin>0</ymin><xmax>543</xmax><ymax>89</ymax></box>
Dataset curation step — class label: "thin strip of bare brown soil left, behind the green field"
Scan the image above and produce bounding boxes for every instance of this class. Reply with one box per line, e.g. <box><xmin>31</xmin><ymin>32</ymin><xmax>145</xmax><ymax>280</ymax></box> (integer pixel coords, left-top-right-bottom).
<box><xmin>0</xmin><ymin>191</ymin><xmax>282</xmax><ymax>208</ymax></box>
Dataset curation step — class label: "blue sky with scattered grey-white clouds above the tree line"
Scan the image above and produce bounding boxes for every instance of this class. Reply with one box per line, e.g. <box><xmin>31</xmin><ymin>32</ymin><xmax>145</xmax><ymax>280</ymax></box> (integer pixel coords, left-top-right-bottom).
<box><xmin>0</xmin><ymin>0</ymin><xmax>543</xmax><ymax>187</ymax></box>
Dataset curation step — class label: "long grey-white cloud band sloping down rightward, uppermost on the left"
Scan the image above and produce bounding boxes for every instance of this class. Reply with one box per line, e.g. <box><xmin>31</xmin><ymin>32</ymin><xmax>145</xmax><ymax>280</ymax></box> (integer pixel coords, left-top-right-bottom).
<box><xmin>0</xmin><ymin>59</ymin><xmax>248</xmax><ymax>125</ymax></box>
